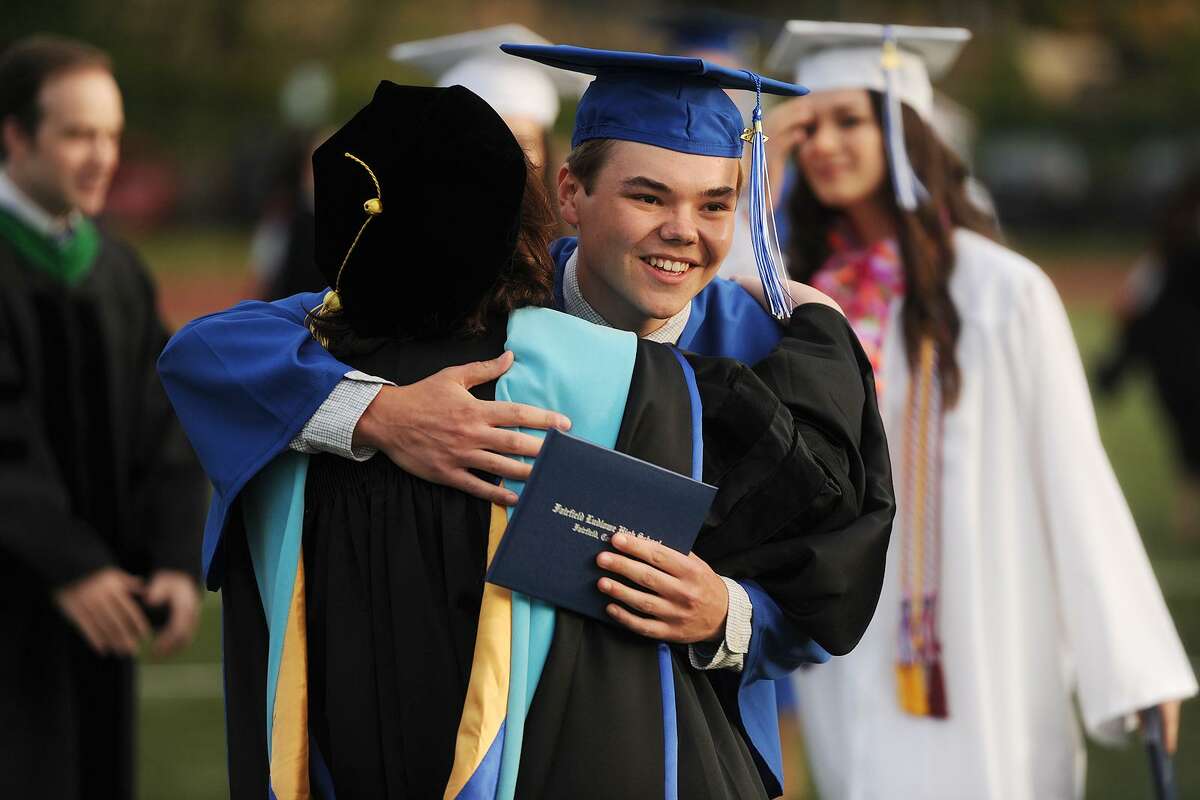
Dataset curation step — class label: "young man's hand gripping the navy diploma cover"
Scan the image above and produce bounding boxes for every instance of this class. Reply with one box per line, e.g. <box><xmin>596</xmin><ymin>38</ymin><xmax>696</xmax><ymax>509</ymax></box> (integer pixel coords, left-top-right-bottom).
<box><xmin>596</xmin><ymin>534</ymin><xmax>730</xmax><ymax>644</ymax></box>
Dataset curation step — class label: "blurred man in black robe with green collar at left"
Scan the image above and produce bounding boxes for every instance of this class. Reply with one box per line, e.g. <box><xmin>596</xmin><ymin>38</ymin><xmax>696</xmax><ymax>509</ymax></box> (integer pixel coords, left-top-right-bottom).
<box><xmin>0</xmin><ymin>36</ymin><xmax>204</xmax><ymax>799</ymax></box>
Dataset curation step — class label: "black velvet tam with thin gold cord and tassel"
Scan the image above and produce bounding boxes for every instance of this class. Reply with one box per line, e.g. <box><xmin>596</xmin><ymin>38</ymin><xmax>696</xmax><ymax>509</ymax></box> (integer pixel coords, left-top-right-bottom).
<box><xmin>312</xmin><ymin>80</ymin><xmax>526</xmax><ymax>338</ymax></box>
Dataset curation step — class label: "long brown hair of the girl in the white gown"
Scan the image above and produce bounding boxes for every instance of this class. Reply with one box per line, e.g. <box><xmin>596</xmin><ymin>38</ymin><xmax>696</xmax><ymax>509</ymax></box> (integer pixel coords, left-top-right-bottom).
<box><xmin>787</xmin><ymin>91</ymin><xmax>998</xmax><ymax>408</ymax></box>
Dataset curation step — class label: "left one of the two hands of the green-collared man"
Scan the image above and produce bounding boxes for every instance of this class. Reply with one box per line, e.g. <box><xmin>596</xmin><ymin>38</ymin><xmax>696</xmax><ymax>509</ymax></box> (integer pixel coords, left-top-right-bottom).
<box><xmin>54</xmin><ymin>566</ymin><xmax>150</xmax><ymax>657</ymax></box>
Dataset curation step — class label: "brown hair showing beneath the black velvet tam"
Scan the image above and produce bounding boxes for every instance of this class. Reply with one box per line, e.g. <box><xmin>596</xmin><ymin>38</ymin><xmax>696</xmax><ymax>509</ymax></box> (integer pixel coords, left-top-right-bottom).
<box><xmin>307</xmin><ymin>157</ymin><xmax>554</xmax><ymax>357</ymax></box>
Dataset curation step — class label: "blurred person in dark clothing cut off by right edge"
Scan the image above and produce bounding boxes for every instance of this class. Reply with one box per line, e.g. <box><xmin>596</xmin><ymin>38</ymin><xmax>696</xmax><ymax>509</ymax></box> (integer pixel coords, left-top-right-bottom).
<box><xmin>1097</xmin><ymin>170</ymin><xmax>1200</xmax><ymax>542</ymax></box>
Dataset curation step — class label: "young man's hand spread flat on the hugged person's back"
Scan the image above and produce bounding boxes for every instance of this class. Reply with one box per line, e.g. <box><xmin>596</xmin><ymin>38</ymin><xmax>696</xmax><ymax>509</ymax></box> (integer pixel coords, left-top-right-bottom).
<box><xmin>354</xmin><ymin>353</ymin><xmax>571</xmax><ymax>505</ymax></box>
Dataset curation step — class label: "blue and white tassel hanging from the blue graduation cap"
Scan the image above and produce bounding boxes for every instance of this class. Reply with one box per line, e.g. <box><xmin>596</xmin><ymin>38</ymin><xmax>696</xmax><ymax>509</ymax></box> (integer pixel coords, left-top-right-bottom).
<box><xmin>742</xmin><ymin>72</ymin><xmax>792</xmax><ymax>320</ymax></box>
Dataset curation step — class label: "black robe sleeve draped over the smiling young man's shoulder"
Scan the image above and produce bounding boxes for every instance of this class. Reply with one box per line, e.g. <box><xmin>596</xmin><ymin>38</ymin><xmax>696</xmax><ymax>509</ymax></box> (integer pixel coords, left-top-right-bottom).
<box><xmin>691</xmin><ymin>303</ymin><xmax>895</xmax><ymax>655</ymax></box>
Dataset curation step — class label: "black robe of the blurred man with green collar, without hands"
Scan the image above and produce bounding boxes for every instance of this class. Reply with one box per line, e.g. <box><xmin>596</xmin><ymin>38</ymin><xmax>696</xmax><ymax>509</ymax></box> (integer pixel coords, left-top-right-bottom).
<box><xmin>0</xmin><ymin>225</ymin><xmax>205</xmax><ymax>800</ymax></box>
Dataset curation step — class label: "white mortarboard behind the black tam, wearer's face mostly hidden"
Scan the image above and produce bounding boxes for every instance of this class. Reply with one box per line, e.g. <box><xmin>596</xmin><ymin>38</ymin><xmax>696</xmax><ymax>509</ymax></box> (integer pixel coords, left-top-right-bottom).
<box><xmin>389</xmin><ymin>24</ymin><xmax>588</xmax><ymax>127</ymax></box>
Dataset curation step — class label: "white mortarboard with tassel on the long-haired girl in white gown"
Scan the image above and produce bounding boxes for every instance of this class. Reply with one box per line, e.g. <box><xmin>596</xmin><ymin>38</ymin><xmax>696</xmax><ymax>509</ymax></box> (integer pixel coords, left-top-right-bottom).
<box><xmin>767</xmin><ymin>19</ymin><xmax>971</xmax><ymax>211</ymax></box>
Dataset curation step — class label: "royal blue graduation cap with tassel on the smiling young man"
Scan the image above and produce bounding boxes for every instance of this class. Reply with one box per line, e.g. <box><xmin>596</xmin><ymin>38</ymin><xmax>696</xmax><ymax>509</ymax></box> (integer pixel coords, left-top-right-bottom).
<box><xmin>500</xmin><ymin>44</ymin><xmax>808</xmax><ymax>319</ymax></box>
